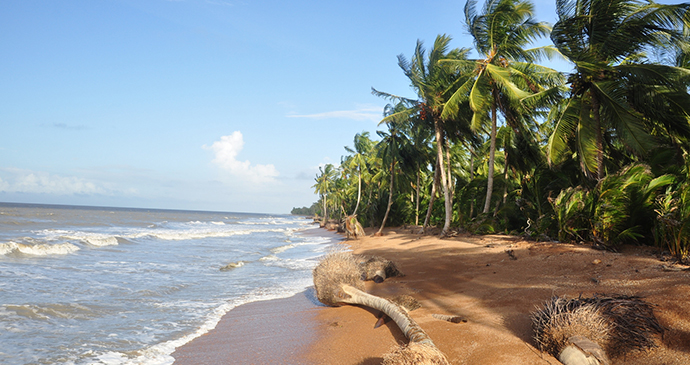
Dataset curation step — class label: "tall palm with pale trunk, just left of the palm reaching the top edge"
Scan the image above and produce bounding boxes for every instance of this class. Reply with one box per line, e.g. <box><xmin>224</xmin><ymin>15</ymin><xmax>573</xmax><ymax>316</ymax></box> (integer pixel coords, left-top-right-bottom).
<box><xmin>372</xmin><ymin>35</ymin><xmax>468</xmax><ymax>235</ymax></box>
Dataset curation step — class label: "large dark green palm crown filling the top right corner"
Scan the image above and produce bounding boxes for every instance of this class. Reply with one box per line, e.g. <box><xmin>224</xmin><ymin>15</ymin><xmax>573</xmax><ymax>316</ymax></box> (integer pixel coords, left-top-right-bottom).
<box><xmin>547</xmin><ymin>0</ymin><xmax>690</xmax><ymax>180</ymax></box>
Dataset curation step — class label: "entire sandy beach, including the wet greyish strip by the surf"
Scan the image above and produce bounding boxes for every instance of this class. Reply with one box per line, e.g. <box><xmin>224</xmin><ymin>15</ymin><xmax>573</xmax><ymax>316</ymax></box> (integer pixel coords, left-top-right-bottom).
<box><xmin>173</xmin><ymin>228</ymin><xmax>690</xmax><ymax>365</ymax></box>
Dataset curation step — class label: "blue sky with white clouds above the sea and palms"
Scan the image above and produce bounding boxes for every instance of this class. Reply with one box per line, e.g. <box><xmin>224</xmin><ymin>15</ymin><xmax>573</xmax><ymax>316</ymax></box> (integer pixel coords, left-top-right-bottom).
<box><xmin>0</xmin><ymin>0</ymin><xmax>564</xmax><ymax>213</ymax></box>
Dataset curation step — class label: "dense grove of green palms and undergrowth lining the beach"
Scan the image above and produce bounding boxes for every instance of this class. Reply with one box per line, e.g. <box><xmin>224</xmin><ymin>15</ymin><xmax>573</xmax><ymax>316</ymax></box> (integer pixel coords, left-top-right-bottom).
<box><xmin>298</xmin><ymin>0</ymin><xmax>690</xmax><ymax>261</ymax></box>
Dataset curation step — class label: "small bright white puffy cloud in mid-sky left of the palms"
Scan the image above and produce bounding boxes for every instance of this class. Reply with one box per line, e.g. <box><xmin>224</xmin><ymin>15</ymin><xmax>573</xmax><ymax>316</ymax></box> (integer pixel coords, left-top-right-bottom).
<box><xmin>203</xmin><ymin>131</ymin><xmax>278</xmax><ymax>183</ymax></box>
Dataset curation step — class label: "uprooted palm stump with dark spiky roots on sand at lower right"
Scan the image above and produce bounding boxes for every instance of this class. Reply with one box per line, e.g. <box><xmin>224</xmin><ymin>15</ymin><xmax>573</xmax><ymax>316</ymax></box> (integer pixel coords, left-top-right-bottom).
<box><xmin>532</xmin><ymin>295</ymin><xmax>662</xmax><ymax>365</ymax></box>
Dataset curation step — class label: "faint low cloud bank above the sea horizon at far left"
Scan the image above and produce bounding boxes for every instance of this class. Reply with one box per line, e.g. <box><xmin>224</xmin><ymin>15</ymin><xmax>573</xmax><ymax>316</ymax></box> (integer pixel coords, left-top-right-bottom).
<box><xmin>0</xmin><ymin>169</ymin><xmax>108</xmax><ymax>195</ymax></box>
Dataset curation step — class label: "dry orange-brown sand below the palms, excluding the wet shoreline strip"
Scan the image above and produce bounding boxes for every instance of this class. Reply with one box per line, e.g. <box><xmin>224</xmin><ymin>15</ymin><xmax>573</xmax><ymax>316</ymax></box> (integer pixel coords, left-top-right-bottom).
<box><xmin>304</xmin><ymin>229</ymin><xmax>690</xmax><ymax>365</ymax></box>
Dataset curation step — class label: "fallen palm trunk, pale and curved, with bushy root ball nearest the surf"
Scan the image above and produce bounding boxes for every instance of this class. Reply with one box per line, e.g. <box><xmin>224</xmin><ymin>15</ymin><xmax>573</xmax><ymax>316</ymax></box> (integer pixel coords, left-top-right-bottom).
<box><xmin>313</xmin><ymin>252</ymin><xmax>448</xmax><ymax>364</ymax></box>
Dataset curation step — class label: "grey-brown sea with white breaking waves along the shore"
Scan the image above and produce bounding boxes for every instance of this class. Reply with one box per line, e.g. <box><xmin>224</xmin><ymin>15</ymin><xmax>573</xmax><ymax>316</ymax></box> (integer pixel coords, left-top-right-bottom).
<box><xmin>0</xmin><ymin>203</ymin><xmax>337</xmax><ymax>365</ymax></box>
